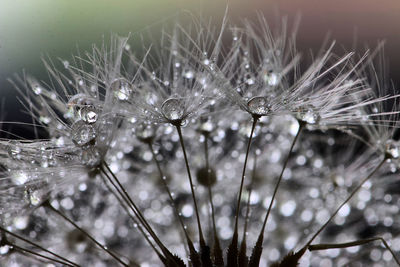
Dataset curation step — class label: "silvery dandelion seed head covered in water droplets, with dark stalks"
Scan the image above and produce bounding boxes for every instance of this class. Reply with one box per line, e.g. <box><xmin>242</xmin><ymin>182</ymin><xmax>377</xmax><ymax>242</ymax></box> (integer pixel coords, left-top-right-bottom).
<box><xmin>0</xmin><ymin>16</ymin><xmax>400</xmax><ymax>267</ymax></box>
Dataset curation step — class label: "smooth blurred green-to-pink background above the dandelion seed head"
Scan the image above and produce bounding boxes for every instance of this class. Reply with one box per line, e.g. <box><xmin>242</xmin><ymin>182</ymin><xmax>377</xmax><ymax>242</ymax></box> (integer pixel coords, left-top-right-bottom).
<box><xmin>0</xmin><ymin>0</ymin><xmax>400</xmax><ymax>137</ymax></box>
